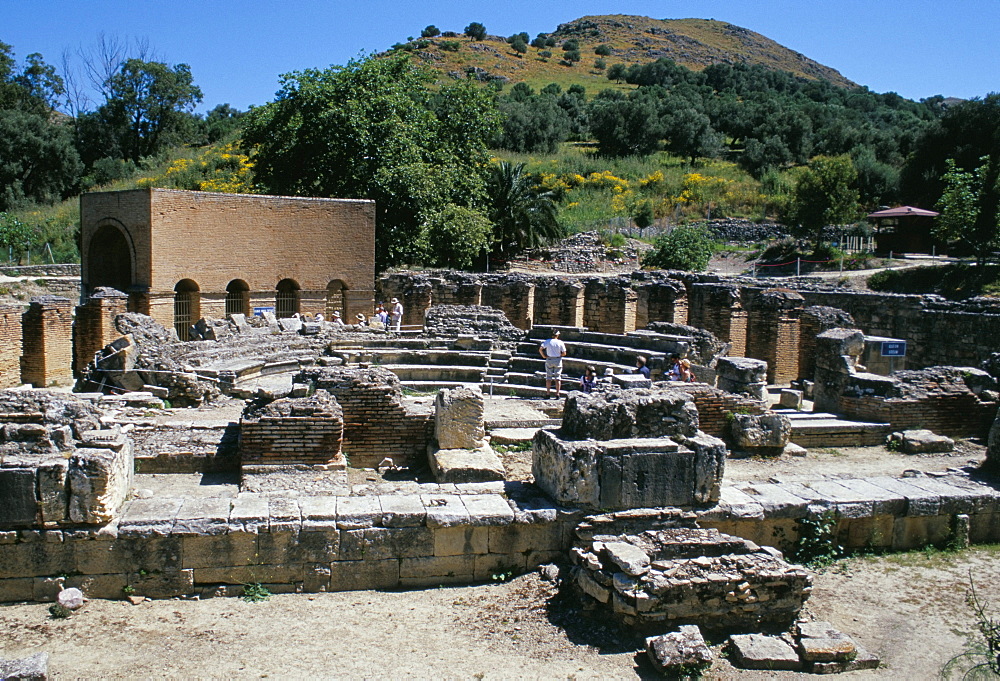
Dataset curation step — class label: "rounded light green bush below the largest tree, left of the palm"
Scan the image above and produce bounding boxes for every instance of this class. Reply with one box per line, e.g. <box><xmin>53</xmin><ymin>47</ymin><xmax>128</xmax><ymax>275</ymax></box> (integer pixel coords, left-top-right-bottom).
<box><xmin>423</xmin><ymin>203</ymin><xmax>493</xmax><ymax>270</ymax></box>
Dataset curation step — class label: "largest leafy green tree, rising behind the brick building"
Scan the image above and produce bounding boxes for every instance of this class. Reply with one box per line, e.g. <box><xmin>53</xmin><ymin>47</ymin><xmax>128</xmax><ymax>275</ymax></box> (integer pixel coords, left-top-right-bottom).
<box><xmin>244</xmin><ymin>54</ymin><xmax>499</xmax><ymax>270</ymax></box>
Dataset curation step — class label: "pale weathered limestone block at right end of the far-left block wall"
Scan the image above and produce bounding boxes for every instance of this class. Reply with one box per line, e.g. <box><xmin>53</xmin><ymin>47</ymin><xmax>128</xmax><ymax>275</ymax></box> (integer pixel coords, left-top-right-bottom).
<box><xmin>66</xmin><ymin>446</ymin><xmax>135</xmax><ymax>524</ymax></box>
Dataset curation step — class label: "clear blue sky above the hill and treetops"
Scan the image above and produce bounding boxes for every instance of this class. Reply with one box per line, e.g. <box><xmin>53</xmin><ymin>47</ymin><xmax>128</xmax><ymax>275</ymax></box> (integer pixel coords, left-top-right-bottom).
<box><xmin>0</xmin><ymin>0</ymin><xmax>1000</xmax><ymax>110</ymax></box>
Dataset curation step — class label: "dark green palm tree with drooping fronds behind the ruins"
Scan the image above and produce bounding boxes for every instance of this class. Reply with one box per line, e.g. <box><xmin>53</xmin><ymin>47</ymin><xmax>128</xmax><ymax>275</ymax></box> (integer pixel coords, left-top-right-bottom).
<box><xmin>487</xmin><ymin>161</ymin><xmax>566</xmax><ymax>260</ymax></box>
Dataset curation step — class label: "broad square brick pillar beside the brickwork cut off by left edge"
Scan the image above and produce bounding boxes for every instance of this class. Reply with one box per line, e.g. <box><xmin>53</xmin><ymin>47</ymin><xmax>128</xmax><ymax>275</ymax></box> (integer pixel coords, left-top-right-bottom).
<box><xmin>21</xmin><ymin>296</ymin><xmax>73</xmax><ymax>388</ymax></box>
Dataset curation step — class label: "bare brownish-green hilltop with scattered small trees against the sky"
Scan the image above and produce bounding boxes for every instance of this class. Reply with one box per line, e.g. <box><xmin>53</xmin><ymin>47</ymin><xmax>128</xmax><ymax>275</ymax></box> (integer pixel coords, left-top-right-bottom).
<box><xmin>396</xmin><ymin>14</ymin><xmax>856</xmax><ymax>90</ymax></box>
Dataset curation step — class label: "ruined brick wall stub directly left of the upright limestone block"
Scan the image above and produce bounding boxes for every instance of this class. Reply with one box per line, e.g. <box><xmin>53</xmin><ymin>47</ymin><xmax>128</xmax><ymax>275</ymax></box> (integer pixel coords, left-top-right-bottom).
<box><xmin>294</xmin><ymin>367</ymin><xmax>434</xmax><ymax>468</ymax></box>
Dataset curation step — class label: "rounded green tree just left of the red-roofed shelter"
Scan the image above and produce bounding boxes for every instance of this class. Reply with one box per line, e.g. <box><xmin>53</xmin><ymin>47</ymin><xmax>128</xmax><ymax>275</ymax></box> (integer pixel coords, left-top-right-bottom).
<box><xmin>792</xmin><ymin>156</ymin><xmax>859</xmax><ymax>251</ymax></box>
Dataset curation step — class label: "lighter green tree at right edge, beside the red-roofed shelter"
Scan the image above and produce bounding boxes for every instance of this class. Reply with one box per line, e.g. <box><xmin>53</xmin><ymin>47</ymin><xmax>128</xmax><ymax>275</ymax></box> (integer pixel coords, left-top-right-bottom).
<box><xmin>934</xmin><ymin>156</ymin><xmax>1000</xmax><ymax>271</ymax></box>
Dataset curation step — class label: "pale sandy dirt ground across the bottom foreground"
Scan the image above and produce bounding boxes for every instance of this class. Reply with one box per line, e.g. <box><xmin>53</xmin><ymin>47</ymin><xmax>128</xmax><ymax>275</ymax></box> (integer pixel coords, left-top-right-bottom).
<box><xmin>0</xmin><ymin>546</ymin><xmax>1000</xmax><ymax>679</ymax></box>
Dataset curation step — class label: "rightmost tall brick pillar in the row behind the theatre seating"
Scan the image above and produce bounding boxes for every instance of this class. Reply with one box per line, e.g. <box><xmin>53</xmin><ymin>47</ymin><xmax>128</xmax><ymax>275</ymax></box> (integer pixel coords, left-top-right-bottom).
<box><xmin>744</xmin><ymin>289</ymin><xmax>804</xmax><ymax>384</ymax></box>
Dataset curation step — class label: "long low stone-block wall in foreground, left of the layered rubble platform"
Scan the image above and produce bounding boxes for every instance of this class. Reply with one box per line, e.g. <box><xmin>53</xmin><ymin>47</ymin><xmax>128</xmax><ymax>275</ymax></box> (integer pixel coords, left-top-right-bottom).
<box><xmin>0</xmin><ymin>483</ymin><xmax>575</xmax><ymax>602</ymax></box>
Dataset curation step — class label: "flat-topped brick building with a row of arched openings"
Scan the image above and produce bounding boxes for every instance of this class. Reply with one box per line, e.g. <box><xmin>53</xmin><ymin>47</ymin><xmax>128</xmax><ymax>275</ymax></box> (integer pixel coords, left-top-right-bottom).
<box><xmin>80</xmin><ymin>188</ymin><xmax>375</xmax><ymax>340</ymax></box>
